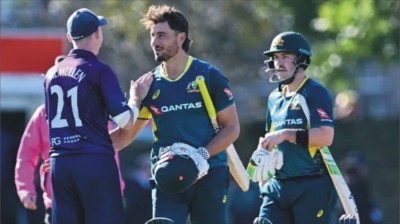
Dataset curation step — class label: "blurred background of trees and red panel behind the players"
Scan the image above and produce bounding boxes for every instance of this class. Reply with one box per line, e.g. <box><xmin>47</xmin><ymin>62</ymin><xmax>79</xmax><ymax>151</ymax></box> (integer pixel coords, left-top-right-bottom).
<box><xmin>0</xmin><ymin>0</ymin><xmax>400</xmax><ymax>224</ymax></box>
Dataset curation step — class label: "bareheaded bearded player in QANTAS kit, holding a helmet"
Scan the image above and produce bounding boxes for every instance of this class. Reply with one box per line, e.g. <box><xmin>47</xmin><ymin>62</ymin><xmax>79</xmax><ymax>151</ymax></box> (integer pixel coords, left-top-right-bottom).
<box><xmin>112</xmin><ymin>5</ymin><xmax>240</xmax><ymax>224</ymax></box>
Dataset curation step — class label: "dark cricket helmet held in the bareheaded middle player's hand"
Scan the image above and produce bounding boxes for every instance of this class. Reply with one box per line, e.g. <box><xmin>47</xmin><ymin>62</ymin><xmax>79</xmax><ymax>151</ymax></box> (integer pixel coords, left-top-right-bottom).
<box><xmin>154</xmin><ymin>155</ymin><xmax>199</xmax><ymax>194</ymax></box>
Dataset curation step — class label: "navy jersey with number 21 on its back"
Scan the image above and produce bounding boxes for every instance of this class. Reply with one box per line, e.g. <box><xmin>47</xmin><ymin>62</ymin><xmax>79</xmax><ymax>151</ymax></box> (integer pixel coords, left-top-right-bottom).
<box><xmin>45</xmin><ymin>49</ymin><xmax>130</xmax><ymax>156</ymax></box>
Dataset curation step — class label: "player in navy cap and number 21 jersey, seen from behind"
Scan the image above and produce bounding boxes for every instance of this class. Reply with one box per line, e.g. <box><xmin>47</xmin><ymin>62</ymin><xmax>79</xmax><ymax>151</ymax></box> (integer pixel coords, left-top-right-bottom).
<box><xmin>45</xmin><ymin>8</ymin><xmax>152</xmax><ymax>224</ymax></box>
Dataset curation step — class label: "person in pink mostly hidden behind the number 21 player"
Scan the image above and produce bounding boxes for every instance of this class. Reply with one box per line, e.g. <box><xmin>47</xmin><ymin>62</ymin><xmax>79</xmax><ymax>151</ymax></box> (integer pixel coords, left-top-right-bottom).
<box><xmin>15</xmin><ymin>104</ymin><xmax>125</xmax><ymax>224</ymax></box>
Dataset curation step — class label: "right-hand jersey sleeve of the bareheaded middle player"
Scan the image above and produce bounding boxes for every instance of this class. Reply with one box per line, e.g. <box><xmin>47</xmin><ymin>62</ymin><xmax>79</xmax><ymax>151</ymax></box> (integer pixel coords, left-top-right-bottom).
<box><xmin>209</xmin><ymin>66</ymin><xmax>235</xmax><ymax>112</ymax></box>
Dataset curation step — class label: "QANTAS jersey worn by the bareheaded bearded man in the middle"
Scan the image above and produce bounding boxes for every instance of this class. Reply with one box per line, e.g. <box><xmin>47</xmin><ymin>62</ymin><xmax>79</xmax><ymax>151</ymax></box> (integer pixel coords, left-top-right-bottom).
<box><xmin>139</xmin><ymin>56</ymin><xmax>234</xmax><ymax>167</ymax></box>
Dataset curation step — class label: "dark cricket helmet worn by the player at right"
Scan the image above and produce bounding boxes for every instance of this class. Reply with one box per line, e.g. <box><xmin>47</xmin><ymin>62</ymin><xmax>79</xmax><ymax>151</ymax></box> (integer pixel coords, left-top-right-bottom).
<box><xmin>264</xmin><ymin>31</ymin><xmax>311</xmax><ymax>70</ymax></box>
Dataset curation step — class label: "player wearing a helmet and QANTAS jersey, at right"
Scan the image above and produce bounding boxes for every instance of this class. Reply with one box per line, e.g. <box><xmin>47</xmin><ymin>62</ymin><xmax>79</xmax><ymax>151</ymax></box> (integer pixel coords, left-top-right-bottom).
<box><xmin>251</xmin><ymin>32</ymin><xmax>336</xmax><ymax>224</ymax></box>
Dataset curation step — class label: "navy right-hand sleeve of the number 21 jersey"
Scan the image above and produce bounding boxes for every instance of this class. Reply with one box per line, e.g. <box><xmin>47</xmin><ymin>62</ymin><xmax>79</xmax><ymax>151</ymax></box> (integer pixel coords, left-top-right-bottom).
<box><xmin>100</xmin><ymin>65</ymin><xmax>130</xmax><ymax>121</ymax></box>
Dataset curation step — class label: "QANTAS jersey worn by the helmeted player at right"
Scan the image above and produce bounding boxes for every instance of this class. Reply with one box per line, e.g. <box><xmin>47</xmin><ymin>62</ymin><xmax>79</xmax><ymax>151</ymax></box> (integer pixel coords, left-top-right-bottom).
<box><xmin>266</xmin><ymin>77</ymin><xmax>333</xmax><ymax>179</ymax></box>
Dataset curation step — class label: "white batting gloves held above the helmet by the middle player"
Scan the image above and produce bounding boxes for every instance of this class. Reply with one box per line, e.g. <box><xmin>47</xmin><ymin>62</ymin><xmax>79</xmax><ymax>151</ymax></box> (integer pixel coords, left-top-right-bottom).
<box><xmin>156</xmin><ymin>142</ymin><xmax>210</xmax><ymax>179</ymax></box>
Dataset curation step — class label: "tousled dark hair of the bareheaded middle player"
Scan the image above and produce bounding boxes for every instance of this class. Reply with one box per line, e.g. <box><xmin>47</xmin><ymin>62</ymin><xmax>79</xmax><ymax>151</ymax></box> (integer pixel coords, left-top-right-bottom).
<box><xmin>140</xmin><ymin>5</ymin><xmax>192</xmax><ymax>52</ymax></box>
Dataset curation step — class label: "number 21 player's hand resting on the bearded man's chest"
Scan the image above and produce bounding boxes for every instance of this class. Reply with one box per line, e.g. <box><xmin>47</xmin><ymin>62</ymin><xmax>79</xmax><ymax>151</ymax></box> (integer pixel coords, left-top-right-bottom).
<box><xmin>128</xmin><ymin>72</ymin><xmax>153</xmax><ymax>106</ymax></box>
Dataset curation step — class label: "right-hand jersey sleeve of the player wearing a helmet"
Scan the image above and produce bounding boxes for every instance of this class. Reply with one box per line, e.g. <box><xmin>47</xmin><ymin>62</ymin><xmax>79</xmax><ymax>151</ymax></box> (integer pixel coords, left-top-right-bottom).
<box><xmin>307</xmin><ymin>86</ymin><xmax>334</xmax><ymax>128</ymax></box>
